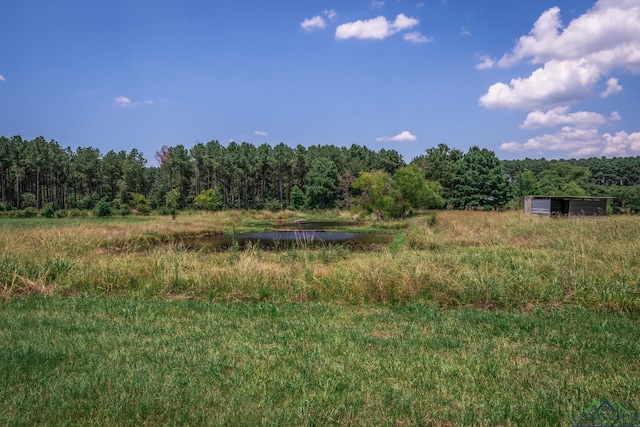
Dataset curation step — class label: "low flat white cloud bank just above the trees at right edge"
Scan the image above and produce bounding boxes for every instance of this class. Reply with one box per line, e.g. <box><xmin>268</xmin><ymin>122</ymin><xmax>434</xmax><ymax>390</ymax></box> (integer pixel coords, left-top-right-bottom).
<box><xmin>500</xmin><ymin>126</ymin><xmax>640</xmax><ymax>157</ymax></box>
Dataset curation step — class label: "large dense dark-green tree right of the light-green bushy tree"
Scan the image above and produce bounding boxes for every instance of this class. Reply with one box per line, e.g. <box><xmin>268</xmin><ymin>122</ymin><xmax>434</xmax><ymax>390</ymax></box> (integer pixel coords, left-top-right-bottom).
<box><xmin>450</xmin><ymin>146</ymin><xmax>509</xmax><ymax>209</ymax></box>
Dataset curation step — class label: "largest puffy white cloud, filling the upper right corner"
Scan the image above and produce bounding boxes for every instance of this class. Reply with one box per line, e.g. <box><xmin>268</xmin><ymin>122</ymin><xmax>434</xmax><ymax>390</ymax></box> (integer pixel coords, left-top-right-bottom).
<box><xmin>477</xmin><ymin>0</ymin><xmax>640</xmax><ymax>110</ymax></box>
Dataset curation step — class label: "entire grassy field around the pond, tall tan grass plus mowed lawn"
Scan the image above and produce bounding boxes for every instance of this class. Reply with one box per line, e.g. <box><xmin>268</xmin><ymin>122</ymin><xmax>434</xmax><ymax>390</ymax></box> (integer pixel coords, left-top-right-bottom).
<box><xmin>0</xmin><ymin>211</ymin><xmax>640</xmax><ymax>426</ymax></box>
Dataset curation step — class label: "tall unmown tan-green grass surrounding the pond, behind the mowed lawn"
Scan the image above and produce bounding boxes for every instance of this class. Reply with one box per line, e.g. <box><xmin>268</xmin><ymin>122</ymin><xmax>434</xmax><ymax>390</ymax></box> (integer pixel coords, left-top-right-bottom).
<box><xmin>0</xmin><ymin>211</ymin><xmax>640</xmax><ymax>312</ymax></box>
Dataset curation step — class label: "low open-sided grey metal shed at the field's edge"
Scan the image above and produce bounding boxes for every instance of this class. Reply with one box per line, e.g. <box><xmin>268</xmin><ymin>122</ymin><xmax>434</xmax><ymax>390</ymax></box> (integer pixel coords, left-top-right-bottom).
<box><xmin>524</xmin><ymin>196</ymin><xmax>611</xmax><ymax>217</ymax></box>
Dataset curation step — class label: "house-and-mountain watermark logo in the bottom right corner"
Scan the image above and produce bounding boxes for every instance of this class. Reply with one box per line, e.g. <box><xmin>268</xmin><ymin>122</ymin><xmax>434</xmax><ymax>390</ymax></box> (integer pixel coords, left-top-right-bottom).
<box><xmin>571</xmin><ymin>400</ymin><xmax>640</xmax><ymax>427</ymax></box>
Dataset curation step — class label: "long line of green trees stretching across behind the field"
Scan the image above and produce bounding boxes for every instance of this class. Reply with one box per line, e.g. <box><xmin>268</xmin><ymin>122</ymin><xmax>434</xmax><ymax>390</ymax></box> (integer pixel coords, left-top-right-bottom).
<box><xmin>0</xmin><ymin>136</ymin><xmax>640</xmax><ymax>217</ymax></box>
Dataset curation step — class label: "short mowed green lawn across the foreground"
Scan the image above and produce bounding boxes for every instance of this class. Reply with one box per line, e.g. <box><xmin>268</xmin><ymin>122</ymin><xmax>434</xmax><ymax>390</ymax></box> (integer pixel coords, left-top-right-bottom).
<box><xmin>0</xmin><ymin>295</ymin><xmax>640</xmax><ymax>426</ymax></box>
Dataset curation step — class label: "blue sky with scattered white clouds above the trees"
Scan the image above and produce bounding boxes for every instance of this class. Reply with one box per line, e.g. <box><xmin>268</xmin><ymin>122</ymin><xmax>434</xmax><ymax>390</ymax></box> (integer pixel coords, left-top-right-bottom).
<box><xmin>0</xmin><ymin>0</ymin><xmax>640</xmax><ymax>164</ymax></box>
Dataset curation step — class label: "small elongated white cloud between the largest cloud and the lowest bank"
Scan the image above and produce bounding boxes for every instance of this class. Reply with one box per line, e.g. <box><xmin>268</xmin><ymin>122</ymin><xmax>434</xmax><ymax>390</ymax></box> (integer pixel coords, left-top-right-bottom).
<box><xmin>520</xmin><ymin>106</ymin><xmax>620</xmax><ymax>129</ymax></box>
